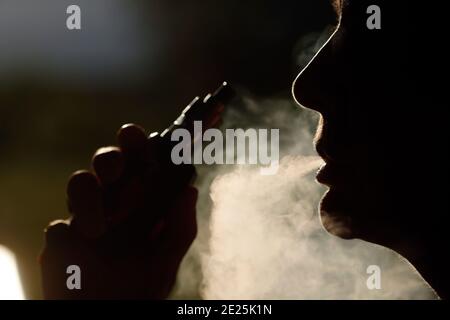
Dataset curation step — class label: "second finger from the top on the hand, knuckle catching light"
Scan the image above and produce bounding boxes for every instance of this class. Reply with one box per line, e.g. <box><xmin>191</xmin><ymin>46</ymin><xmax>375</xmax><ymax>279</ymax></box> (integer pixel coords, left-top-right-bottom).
<box><xmin>92</xmin><ymin>147</ymin><xmax>125</xmax><ymax>185</ymax></box>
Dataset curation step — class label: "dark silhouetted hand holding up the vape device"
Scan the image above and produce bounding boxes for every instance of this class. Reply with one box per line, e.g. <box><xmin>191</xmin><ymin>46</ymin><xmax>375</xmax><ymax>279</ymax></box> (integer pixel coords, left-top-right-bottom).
<box><xmin>40</xmin><ymin>125</ymin><xmax>197</xmax><ymax>299</ymax></box>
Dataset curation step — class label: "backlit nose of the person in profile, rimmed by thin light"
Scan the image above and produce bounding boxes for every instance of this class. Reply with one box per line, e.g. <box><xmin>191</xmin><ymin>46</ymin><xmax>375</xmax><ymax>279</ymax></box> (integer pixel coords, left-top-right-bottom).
<box><xmin>292</xmin><ymin>27</ymin><xmax>339</xmax><ymax>114</ymax></box>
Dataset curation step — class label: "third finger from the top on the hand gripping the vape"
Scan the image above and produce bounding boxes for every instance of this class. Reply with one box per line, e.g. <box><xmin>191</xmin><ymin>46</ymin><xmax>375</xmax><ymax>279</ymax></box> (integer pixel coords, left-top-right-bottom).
<box><xmin>67</xmin><ymin>170</ymin><xmax>105</xmax><ymax>238</ymax></box>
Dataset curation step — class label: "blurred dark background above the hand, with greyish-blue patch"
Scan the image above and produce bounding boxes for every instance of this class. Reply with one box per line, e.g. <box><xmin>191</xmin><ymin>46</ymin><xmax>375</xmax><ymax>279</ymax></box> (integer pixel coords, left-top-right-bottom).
<box><xmin>0</xmin><ymin>0</ymin><xmax>335</xmax><ymax>298</ymax></box>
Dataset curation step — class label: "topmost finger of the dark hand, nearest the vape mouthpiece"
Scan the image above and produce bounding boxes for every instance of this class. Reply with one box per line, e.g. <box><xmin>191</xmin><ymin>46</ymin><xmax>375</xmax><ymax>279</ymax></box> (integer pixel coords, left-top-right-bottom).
<box><xmin>117</xmin><ymin>123</ymin><xmax>147</xmax><ymax>157</ymax></box>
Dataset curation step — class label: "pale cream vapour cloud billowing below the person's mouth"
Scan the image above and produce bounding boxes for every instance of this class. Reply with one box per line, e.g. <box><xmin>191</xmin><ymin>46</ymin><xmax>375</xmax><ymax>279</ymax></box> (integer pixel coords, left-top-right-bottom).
<box><xmin>173</xmin><ymin>93</ymin><xmax>436</xmax><ymax>299</ymax></box>
